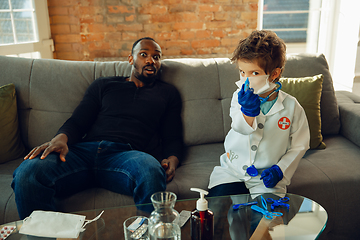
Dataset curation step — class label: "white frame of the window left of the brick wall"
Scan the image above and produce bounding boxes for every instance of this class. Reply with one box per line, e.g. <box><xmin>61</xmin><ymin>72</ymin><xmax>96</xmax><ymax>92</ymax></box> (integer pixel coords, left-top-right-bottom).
<box><xmin>0</xmin><ymin>0</ymin><xmax>54</xmax><ymax>59</ymax></box>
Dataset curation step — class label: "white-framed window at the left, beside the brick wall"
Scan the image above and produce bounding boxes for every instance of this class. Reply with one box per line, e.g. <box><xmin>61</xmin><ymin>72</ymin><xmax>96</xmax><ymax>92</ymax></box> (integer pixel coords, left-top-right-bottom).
<box><xmin>0</xmin><ymin>0</ymin><xmax>53</xmax><ymax>58</ymax></box>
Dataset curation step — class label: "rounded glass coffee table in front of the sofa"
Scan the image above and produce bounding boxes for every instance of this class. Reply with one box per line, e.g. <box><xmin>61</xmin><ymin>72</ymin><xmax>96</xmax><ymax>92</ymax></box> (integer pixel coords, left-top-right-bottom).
<box><xmin>1</xmin><ymin>194</ymin><xmax>327</xmax><ymax>240</ymax></box>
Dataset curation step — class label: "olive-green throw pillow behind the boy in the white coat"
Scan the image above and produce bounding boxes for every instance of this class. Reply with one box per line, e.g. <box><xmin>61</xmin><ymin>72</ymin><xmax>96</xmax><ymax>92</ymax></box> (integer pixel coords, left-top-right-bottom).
<box><xmin>280</xmin><ymin>74</ymin><xmax>326</xmax><ymax>149</ymax></box>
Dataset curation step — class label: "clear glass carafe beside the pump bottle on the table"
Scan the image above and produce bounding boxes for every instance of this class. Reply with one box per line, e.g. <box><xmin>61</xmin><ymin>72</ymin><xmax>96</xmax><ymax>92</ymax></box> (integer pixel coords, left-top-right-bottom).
<box><xmin>149</xmin><ymin>192</ymin><xmax>181</xmax><ymax>240</ymax></box>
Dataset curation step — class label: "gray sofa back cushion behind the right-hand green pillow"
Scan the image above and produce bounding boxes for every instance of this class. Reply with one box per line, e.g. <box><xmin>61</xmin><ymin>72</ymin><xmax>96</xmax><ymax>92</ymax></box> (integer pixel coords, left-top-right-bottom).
<box><xmin>282</xmin><ymin>54</ymin><xmax>340</xmax><ymax>136</ymax></box>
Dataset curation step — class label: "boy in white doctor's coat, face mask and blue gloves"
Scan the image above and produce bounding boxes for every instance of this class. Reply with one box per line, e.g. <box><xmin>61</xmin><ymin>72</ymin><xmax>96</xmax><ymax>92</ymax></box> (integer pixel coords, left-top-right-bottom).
<box><xmin>209</xmin><ymin>30</ymin><xmax>310</xmax><ymax>196</ymax></box>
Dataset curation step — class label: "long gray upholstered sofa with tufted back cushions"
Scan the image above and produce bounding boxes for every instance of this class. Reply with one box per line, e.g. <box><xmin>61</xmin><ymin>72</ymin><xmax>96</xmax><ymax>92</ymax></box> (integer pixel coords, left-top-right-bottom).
<box><xmin>0</xmin><ymin>55</ymin><xmax>360</xmax><ymax>239</ymax></box>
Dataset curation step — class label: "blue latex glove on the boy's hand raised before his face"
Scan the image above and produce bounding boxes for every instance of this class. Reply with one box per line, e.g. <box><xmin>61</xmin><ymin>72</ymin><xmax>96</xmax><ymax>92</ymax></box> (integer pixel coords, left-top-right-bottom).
<box><xmin>238</xmin><ymin>78</ymin><xmax>261</xmax><ymax>117</ymax></box>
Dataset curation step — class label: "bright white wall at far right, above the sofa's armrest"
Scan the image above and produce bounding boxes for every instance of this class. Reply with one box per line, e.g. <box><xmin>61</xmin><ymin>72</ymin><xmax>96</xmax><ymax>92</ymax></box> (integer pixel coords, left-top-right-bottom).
<box><xmin>318</xmin><ymin>0</ymin><xmax>360</xmax><ymax>91</ymax></box>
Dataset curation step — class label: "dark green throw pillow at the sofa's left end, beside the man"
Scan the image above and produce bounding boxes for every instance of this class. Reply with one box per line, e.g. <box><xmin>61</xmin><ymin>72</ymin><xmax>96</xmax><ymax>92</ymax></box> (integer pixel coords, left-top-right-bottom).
<box><xmin>0</xmin><ymin>84</ymin><xmax>25</xmax><ymax>163</ymax></box>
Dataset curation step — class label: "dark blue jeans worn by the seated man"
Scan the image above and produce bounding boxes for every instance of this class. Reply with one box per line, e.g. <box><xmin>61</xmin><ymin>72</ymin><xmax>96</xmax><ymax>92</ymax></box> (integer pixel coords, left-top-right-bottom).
<box><xmin>11</xmin><ymin>141</ymin><xmax>166</xmax><ymax>219</ymax></box>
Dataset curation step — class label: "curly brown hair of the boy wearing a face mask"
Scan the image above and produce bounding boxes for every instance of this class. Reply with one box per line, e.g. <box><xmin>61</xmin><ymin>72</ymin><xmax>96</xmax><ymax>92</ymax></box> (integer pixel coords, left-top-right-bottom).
<box><xmin>231</xmin><ymin>30</ymin><xmax>286</xmax><ymax>81</ymax></box>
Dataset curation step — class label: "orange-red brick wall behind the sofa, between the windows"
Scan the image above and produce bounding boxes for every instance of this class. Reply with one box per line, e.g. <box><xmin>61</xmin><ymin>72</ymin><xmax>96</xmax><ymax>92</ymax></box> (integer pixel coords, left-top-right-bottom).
<box><xmin>48</xmin><ymin>0</ymin><xmax>258</xmax><ymax>60</ymax></box>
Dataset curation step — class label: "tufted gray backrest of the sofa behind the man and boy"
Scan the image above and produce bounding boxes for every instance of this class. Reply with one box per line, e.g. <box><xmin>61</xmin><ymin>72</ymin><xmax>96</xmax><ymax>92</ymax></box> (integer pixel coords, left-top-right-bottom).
<box><xmin>0</xmin><ymin>55</ymin><xmax>340</xmax><ymax>148</ymax></box>
